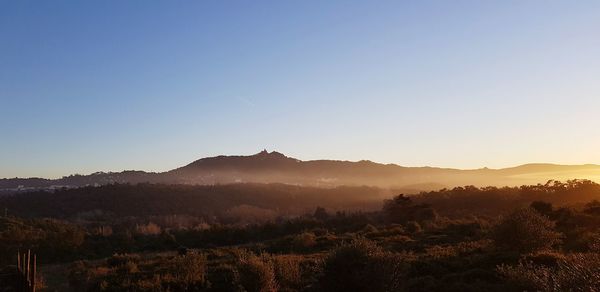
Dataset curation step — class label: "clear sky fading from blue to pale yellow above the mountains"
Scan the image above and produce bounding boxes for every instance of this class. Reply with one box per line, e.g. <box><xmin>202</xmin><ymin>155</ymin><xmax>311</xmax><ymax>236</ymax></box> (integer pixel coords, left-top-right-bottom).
<box><xmin>0</xmin><ymin>0</ymin><xmax>600</xmax><ymax>178</ymax></box>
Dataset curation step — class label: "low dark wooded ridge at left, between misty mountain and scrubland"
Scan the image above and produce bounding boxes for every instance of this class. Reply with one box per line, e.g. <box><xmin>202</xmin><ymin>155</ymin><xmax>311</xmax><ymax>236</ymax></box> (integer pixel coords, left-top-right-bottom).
<box><xmin>0</xmin><ymin>184</ymin><xmax>390</xmax><ymax>219</ymax></box>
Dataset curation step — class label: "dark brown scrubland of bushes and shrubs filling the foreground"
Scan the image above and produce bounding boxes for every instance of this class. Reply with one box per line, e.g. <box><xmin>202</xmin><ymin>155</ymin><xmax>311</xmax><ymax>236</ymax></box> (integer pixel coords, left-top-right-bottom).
<box><xmin>0</xmin><ymin>181</ymin><xmax>600</xmax><ymax>291</ymax></box>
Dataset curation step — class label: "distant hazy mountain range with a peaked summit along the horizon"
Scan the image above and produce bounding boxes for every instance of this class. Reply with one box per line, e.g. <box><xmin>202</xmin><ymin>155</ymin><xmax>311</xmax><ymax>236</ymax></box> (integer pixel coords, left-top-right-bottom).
<box><xmin>0</xmin><ymin>150</ymin><xmax>600</xmax><ymax>193</ymax></box>
